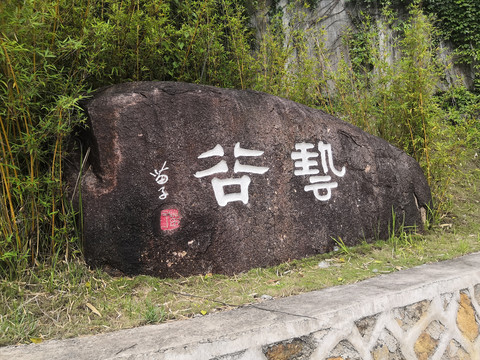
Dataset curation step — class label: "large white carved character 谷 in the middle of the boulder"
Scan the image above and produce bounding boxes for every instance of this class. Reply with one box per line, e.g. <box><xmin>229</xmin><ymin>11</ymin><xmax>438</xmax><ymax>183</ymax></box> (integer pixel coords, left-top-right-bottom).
<box><xmin>194</xmin><ymin>143</ymin><xmax>268</xmax><ymax>206</ymax></box>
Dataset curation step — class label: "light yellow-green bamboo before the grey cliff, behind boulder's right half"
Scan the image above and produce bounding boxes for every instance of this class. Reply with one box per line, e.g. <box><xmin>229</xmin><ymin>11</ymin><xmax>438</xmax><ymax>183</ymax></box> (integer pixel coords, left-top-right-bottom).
<box><xmin>255</xmin><ymin>1</ymin><xmax>456</xmax><ymax>206</ymax></box>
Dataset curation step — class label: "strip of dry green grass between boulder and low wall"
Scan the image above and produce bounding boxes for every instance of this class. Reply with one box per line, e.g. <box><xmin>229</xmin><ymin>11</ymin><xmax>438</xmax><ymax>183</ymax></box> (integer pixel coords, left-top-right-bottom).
<box><xmin>0</xmin><ymin>152</ymin><xmax>480</xmax><ymax>346</ymax></box>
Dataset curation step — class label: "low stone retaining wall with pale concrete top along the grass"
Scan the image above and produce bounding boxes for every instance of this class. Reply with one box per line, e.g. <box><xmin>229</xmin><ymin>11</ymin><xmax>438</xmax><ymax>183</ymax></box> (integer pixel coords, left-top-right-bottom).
<box><xmin>0</xmin><ymin>253</ymin><xmax>480</xmax><ymax>360</ymax></box>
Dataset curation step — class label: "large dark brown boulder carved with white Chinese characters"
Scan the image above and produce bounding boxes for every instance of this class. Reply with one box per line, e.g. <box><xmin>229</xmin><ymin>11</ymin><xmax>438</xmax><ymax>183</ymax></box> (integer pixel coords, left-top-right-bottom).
<box><xmin>75</xmin><ymin>82</ymin><xmax>431</xmax><ymax>277</ymax></box>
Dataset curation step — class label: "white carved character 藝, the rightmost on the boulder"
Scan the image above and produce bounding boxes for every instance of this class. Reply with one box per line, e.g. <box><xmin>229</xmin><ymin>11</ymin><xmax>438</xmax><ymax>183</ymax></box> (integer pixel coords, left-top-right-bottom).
<box><xmin>291</xmin><ymin>141</ymin><xmax>346</xmax><ymax>201</ymax></box>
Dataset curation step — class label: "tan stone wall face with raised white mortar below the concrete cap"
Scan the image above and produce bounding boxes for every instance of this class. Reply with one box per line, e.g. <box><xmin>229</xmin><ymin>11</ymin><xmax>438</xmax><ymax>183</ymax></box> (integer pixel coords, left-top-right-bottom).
<box><xmin>260</xmin><ymin>284</ymin><xmax>480</xmax><ymax>360</ymax></box>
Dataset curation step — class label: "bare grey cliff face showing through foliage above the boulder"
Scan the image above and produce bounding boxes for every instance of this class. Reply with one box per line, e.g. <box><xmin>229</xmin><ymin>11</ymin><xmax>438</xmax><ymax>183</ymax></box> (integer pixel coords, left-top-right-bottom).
<box><xmin>253</xmin><ymin>0</ymin><xmax>475</xmax><ymax>88</ymax></box>
